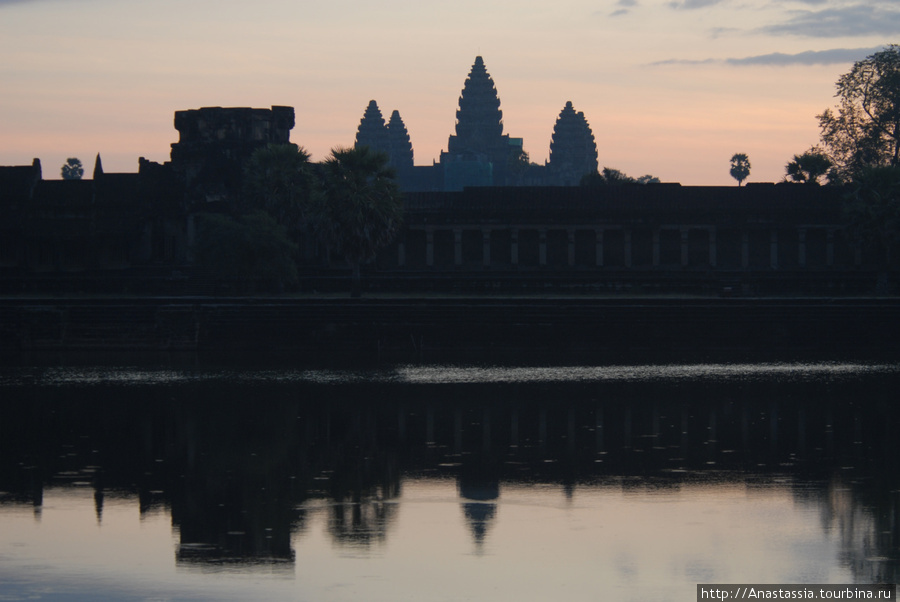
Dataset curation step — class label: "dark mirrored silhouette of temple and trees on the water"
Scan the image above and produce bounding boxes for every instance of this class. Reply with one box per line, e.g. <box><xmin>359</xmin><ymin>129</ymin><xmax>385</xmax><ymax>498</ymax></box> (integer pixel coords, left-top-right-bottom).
<box><xmin>0</xmin><ymin>364</ymin><xmax>900</xmax><ymax>582</ymax></box>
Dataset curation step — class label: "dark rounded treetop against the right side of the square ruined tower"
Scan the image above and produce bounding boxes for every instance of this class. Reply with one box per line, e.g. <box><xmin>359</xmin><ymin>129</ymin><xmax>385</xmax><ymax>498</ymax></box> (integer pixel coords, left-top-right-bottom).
<box><xmin>242</xmin><ymin>144</ymin><xmax>315</xmax><ymax>229</ymax></box>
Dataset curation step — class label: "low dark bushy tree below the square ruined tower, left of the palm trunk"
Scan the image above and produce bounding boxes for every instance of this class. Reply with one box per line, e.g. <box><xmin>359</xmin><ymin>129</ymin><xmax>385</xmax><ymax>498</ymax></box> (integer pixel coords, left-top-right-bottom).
<box><xmin>196</xmin><ymin>211</ymin><xmax>297</xmax><ymax>290</ymax></box>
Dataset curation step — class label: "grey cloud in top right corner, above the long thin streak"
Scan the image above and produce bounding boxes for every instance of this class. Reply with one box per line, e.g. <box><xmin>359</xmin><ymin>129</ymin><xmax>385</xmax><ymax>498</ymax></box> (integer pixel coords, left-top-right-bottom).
<box><xmin>758</xmin><ymin>2</ymin><xmax>900</xmax><ymax>38</ymax></box>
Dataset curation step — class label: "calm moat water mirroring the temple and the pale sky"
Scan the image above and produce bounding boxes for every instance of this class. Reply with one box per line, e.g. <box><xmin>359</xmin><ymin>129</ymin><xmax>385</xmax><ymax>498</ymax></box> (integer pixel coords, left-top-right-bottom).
<box><xmin>0</xmin><ymin>361</ymin><xmax>900</xmax><ymax>602</ymax></box>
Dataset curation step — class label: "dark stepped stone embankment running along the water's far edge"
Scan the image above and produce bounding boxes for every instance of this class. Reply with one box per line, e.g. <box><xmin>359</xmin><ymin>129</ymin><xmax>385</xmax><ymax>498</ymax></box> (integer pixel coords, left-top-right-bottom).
<box><xmin>0</xmin><ymin>295</ymin><xmax>900</xmax><ymax>358</ymax></box>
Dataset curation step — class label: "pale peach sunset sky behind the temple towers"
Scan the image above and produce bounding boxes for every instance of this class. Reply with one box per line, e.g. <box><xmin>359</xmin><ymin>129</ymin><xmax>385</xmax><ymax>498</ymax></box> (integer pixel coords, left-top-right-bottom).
<box><xmin>0</xmin><ymin>0</ymin><xmax>900</xmax><ymax>185</ymax></box>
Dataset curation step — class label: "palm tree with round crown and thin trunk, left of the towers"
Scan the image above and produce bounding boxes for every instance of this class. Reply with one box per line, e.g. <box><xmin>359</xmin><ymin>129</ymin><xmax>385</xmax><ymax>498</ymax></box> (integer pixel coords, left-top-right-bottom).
<box><xmin>308</xmin><ymin>146</ymin><xmax>403</xmax><ymax>297</ymax></box>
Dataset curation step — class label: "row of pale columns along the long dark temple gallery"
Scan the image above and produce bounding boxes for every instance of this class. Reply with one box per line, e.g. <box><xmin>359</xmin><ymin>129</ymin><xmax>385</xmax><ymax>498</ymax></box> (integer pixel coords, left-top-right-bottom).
<box><xmin>390</xmin><ymin>224</ymin><xmax>862</xmax><ymax>270</ymax></box>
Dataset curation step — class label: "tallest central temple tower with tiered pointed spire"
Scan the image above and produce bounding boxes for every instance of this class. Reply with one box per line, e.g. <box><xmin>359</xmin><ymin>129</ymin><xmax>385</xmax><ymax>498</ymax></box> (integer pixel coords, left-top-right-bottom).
<box><xmin>441</xmin><ymin>56</ymin><xmax>520</xmax><ymax>190</ymax></box>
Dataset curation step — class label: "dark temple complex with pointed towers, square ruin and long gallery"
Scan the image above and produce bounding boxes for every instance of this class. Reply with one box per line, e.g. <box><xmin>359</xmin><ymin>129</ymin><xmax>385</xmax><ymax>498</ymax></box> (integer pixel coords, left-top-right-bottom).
<box><xmin>0</xmin><ymin>57</ymin><xmax>900</xmax><ymax>294</ymax></box>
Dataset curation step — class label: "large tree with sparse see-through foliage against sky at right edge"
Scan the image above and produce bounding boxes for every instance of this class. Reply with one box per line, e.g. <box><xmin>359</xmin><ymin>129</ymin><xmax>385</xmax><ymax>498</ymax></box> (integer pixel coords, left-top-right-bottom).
<box><xmin>817</xmin><ymin>44</ymin><xmax>900</xmax><ymax>180</ymax></box>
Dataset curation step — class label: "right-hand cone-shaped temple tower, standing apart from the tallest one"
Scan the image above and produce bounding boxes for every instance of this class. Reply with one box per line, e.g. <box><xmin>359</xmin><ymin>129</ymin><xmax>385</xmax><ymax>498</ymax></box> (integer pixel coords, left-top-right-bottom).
<box><xmin>547</xmin><ymin>101</ymin><xmax>598</xmax><ymax>186</ymax></box>
